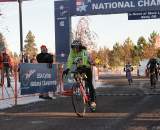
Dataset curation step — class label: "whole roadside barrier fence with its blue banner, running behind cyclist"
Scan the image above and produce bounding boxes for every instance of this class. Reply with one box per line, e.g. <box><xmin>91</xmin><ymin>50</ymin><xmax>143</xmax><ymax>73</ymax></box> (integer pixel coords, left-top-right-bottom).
<box><xmin>0</xmin><ymin>63</ymin><xmax>97</xmax><ymax>108</ymax></box>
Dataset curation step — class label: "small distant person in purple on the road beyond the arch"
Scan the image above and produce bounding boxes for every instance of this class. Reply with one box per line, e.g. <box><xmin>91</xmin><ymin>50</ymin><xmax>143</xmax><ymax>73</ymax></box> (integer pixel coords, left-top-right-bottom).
<box><xmin>124</xmin><ymin>62</ymin><xmax>133</xmax><ymax>85</ymax></box>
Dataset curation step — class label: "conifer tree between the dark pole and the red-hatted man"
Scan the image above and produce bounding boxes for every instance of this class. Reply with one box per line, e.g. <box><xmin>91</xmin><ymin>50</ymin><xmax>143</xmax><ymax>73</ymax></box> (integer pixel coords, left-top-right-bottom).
<box><xmin>24</xmin><ymin>31</ymin><xmax>38</xmax><ymax>58</ymax></box>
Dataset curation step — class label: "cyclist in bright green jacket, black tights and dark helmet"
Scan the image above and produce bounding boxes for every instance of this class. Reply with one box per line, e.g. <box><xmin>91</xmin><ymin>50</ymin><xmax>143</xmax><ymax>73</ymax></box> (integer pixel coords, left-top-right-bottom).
<box><xmin>63</xmin><ymin>40</ymin><xmax>96</xmax><ymax>109</ymax></box>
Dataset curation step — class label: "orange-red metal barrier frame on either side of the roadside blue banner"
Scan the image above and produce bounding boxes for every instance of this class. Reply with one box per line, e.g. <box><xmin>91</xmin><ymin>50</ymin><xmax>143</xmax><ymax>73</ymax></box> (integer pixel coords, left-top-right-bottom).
<box><xmin>0</xmin><ymin>63</ymin><xmax>63</xmax><ymax>109</ymax></box>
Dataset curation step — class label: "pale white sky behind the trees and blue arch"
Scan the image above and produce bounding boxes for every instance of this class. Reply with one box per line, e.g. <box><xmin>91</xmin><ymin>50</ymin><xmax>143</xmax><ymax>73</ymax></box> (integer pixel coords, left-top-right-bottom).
<box><xmin>0</xmin><ymin>0</ymin><xmax>160</xmax><ymax>53</ymax></box>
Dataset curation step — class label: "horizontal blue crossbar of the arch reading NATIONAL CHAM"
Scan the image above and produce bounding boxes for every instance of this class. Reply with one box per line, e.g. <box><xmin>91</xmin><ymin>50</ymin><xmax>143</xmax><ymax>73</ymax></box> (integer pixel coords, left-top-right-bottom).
<box><xmin>70</xmin><ymin>0</ymin><xmax>160</xmax><ymax>16</ymax></box>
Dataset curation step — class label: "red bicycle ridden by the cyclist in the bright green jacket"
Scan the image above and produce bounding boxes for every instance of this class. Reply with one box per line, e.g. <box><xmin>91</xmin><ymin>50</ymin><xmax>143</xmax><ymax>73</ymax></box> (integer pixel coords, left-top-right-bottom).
<box><xmin>71</xmin><ymin>70</ymin><xmax>95</xmax><ymax>117</ymax></box>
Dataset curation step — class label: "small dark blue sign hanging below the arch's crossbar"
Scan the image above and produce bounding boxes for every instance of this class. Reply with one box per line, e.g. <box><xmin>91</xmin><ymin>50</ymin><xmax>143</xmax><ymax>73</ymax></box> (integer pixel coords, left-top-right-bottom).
<box><xmin>128</xmin><ymin>10</ymin><xmax>160</xmax><ymax>20</ymax></box>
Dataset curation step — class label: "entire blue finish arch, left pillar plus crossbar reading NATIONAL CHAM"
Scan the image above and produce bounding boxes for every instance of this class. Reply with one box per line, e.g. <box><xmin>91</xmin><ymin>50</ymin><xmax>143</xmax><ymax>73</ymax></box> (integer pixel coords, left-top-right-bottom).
<box><xmin>54</xmin><ymin>0</ymin><xmax>160</xmax><ymax>63</ymax></box>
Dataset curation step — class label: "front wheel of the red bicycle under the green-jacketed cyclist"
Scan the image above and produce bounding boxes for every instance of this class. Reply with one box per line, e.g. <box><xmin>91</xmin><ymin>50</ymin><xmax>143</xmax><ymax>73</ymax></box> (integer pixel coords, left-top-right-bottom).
<box><xmin>72</xmin><ymin>84</ymin><xmax>87</xmax><ymax>117</ymax></box>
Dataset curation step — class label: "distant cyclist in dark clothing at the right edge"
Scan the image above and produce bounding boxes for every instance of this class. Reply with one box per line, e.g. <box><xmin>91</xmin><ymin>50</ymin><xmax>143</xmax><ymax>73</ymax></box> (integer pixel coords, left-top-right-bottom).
<box><xmin>147</xmin><ymin>57</ymin><xmax>159</xmax><ymax>80</ymax></box>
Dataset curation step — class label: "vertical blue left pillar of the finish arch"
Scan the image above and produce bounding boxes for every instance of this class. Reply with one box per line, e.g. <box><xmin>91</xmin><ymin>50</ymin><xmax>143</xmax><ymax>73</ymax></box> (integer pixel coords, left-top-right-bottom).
<box><xmin>54</xmin><ymin>1</ymin><xmax>71</xmax><ymax>62</ymax></box>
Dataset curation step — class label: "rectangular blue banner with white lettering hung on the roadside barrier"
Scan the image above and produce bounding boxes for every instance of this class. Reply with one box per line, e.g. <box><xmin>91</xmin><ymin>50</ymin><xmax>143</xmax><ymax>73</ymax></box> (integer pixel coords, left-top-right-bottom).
<box><xmin>20</xmin><ymin>63</ymin><xmax>57</xmax><ymax>95</ymax></box>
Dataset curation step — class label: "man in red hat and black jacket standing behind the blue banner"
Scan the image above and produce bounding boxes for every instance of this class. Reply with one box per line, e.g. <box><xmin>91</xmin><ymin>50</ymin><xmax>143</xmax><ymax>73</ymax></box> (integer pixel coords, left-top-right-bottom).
<box><xmin>36</xmin><ymin>45</ymin><xmax>53</xmax><ymax>99</ymax></box>
